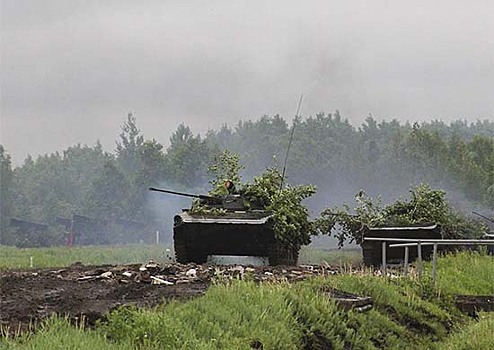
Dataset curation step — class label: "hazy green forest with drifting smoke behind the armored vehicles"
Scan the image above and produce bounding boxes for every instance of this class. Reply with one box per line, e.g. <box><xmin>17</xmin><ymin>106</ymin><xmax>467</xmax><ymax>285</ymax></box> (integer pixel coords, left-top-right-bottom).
<box><xmin>0</xmin><ymin>111</ymin><xmax>494</xmax><ymax>247</ymax></box>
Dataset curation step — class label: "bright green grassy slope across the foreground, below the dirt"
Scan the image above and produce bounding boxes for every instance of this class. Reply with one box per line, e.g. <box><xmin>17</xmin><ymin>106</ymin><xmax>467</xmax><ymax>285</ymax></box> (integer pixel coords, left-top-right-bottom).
<box><xmin>0</xmin><ymin>247</ymin><xmax>494</xmax><ymax>350</ymax></box>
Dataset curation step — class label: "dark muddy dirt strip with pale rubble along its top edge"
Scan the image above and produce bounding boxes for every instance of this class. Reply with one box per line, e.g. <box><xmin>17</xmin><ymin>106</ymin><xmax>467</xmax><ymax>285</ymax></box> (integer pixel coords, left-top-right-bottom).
<box><xmin>0</xmin><ymin>262</ymin><xmax>336</xmax><ymax>333</ymax></box>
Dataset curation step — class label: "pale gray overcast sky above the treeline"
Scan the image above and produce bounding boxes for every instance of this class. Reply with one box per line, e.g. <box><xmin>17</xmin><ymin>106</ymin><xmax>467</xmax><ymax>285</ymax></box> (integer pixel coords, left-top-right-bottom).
<box><xmin>0</xmin><ymin>0</ymin><xmax>494</xmax><ymax>164</ymax></box>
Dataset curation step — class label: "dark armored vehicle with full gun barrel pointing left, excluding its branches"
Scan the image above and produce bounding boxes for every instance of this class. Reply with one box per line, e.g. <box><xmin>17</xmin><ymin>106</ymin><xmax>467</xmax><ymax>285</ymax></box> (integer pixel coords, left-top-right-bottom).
<box><xmin>150</xmin><ymin>188</ymin><xmax>300</xmax><ymax>265</ymax></box>
